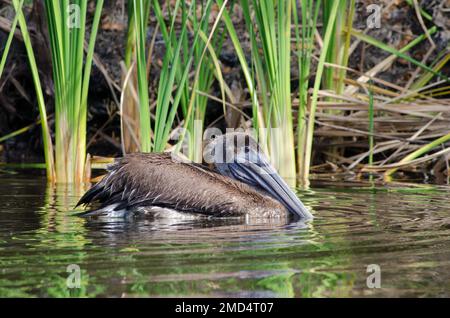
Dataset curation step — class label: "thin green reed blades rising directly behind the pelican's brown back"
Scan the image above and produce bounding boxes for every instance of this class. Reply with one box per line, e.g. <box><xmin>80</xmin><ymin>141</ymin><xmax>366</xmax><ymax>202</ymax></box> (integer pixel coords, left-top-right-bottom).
<box><xmin>122</xmin><ymin>0</ymin><xmax>223</xmax><ymax>161</ymax></box>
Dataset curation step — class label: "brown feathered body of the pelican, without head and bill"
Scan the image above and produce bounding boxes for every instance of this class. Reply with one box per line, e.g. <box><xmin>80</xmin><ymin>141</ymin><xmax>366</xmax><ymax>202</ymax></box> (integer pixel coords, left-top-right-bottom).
<box><xmin>78</xmin><ymin>153</ymin><xmax>287</xmax><ymax>217</ymax></box>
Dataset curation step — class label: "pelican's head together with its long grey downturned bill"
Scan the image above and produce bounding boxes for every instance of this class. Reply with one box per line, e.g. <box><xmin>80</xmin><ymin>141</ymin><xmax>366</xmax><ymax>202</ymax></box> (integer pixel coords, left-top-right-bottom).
<box><xmin>204</xmin><ymin>132</ymin><xmax>312</xmax><ymax>218</ymax></box>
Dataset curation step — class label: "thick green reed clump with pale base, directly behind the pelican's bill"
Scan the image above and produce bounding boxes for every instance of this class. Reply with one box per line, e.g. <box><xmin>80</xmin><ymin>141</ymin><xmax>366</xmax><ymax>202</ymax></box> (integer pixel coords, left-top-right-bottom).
<box><xmin>237</xmin><ymin>0</ymin><xmax>296</xmax><ymax>185</ymax></box>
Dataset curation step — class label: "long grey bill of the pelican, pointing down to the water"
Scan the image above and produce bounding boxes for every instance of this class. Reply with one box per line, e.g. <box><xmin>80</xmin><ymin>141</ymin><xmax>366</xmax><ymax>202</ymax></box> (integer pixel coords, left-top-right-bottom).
<box><xmin>216</xmin><ymin>143</ymin><xmax>313</xmax><ymax>219</ymax></box>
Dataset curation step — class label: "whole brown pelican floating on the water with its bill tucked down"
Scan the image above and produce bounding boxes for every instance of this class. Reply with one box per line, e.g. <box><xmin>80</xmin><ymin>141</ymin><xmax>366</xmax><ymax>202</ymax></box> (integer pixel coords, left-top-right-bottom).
<box><xmin>77</xmin><ymin>133</ymin><xmax>312</xmax><ymax>219</ymax></box>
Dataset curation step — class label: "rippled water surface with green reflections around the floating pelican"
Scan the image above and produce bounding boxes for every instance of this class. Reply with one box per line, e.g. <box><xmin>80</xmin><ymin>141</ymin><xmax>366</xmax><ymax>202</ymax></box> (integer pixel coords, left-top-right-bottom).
<box><xmin>0</xmin><ymin>176</ymin><xmax>450</xmax><ymax>297</ymax></box>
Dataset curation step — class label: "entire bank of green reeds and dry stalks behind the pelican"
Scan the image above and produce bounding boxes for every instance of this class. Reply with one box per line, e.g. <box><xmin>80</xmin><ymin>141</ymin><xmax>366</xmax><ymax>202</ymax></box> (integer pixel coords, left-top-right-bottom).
<box><xmin>0</xmin><ymin>0</ymin><xmax>450</xmax><ymax>186</ymax></box>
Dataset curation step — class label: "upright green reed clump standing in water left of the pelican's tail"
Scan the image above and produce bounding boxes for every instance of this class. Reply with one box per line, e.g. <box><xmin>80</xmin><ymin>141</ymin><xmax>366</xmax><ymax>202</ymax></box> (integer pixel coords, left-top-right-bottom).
<box><xmin>45</xmin><ymin>0</ymin><xmax>103</xmax><ymax>183</ymax></box>
